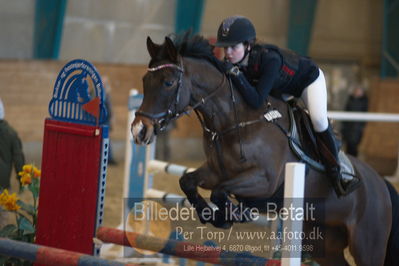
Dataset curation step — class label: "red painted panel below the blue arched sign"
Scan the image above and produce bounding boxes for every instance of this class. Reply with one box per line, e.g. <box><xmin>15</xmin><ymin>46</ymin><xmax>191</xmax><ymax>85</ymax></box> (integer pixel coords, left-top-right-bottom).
<box><xmin>36</xmin><ymin>119</ymin><xmax>102</xmax><ymax>254</ymax></box>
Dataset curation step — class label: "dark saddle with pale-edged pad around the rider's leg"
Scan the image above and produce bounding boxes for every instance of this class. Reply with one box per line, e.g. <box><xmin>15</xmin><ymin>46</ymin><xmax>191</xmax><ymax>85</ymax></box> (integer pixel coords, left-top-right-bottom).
<box><xmin>287</xmin><ymin>99</ymin><xmax>355</xmax><ymax>179</ymax></box>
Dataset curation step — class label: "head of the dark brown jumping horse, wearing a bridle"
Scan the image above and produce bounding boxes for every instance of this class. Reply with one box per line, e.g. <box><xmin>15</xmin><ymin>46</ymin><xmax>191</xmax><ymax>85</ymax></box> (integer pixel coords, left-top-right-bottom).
<box><xmin>131</xmin><ymin>37</ymin><xmax>190</xmax><ymax>144</ymax></box>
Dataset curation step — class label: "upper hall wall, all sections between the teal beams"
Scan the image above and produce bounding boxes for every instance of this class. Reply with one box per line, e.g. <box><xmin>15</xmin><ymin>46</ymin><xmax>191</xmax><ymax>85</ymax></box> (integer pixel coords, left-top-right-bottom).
<box><xmin>0</xmin><ymin>0</ymin><xmax>383</xmax><ymax>66</ymax></box>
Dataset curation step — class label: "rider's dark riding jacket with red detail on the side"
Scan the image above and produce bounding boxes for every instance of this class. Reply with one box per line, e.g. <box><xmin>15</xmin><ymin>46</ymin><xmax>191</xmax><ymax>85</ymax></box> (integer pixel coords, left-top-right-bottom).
<box><xmin>230</xmin><ymin>44</ymin><xmax>319</xmax><ymax>108</ymax></box>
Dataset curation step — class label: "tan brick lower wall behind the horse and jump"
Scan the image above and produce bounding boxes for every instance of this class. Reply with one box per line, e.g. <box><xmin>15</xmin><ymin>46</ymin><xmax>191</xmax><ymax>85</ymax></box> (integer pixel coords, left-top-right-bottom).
<box><xmin>0</xmin><ymin>60</ymin><xmax>399</xmax><ymax>174</ymax></box>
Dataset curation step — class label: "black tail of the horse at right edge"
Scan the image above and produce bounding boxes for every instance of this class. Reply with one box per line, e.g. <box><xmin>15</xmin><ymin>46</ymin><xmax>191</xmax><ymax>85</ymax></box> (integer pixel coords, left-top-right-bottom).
<box><xmin>384</xmin><ymin>181</ymin><xmax>399</xmax><ymax>266</ymax></box>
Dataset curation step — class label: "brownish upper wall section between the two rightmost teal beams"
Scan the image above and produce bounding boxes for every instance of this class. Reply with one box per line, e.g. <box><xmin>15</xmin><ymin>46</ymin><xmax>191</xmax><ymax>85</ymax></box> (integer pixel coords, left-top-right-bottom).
<box><xmin>310</xmin><ymin>0</ymin><xmax>383</xmax><ymax>66</ymax></box>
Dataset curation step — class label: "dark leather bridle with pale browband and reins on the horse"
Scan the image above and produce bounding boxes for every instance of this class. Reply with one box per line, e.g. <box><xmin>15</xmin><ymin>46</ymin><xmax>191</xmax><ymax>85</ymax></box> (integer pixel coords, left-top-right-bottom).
<box><xmin>135</xmin><ymin>62</ymin><xmax>226</xmax><ymax>134</ymax></box>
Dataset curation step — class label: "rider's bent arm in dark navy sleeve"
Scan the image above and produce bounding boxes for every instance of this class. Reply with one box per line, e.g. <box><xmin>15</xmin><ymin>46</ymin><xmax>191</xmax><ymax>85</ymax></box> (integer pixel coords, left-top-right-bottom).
<box><xmin>230</xmin><ymin>53</ymin><xmax>281</xmax><ymax>108</ymax></box>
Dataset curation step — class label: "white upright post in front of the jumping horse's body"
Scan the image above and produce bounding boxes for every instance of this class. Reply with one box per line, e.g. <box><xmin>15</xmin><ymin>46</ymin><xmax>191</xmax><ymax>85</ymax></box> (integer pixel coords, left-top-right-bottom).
<box><xmin>281</xmin><ymin>163</ymin><xmax>305</xmax><ymax>266</ymax></box>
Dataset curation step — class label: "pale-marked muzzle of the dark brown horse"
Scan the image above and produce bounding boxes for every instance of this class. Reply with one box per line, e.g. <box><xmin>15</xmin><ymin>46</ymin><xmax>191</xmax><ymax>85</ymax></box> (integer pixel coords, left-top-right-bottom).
<box><xmin>131</xmin><ymin>116</ymin><xmax>155</xmax><ymax>145</ymax></box>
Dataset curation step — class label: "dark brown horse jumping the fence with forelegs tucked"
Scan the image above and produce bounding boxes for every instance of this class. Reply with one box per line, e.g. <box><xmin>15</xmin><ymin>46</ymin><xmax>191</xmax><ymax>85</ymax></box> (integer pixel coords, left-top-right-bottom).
<box><xmin>131</xmin><ymin>35</ymin><xmax>399</xmax><ymax>266</ymax></box>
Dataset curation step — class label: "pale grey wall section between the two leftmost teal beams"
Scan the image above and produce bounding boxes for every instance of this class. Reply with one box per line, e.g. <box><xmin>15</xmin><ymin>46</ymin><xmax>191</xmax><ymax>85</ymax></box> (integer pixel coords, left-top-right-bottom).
<box><xmin>60</xmin><ymin>0</ymin><xmax>175</xmax><ymax>64</ymax></box>
